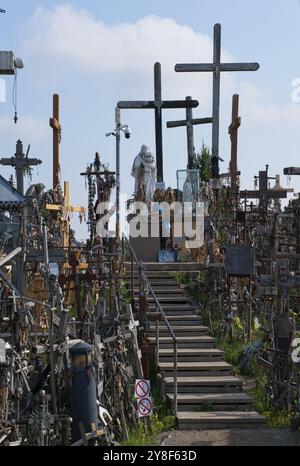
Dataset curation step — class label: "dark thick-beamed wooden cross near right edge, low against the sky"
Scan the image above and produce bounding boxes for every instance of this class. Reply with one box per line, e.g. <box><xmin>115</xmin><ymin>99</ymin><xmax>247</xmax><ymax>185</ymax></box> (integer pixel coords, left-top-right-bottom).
<box><xmin>240</xmin><ymin>165</ymin><xmax>294</xmax><ymax>209</ymax></box>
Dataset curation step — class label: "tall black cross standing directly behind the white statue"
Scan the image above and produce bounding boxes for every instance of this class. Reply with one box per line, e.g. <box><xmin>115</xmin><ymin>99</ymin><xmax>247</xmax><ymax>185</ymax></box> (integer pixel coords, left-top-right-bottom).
<box><xmin>117</xmin><ymin>62</ymin><xmax>199</xmax><ymax>182</ymax></box>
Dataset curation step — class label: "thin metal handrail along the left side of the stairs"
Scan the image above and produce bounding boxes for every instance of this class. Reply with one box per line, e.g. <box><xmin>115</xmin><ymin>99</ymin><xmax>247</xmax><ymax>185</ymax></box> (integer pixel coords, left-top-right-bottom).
<box><xmin>122</xmin><ymin>233</ymin><xmax>178</xmax><ymax>417</ymax></box>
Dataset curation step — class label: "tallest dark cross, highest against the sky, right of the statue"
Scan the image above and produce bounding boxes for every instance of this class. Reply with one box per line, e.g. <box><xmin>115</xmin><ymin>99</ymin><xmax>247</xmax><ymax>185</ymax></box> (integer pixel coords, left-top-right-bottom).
<box><xmin>175</xmin><ymin>24</ymin><xmax>259</xmax><ymax>178</ymax></box>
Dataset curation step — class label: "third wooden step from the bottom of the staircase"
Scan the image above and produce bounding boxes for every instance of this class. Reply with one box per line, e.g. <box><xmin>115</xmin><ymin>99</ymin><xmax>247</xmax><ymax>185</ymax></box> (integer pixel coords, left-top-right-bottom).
<box><xmin>158</xmin><ymin>374</ymin><xmax>243</xmax><ymax>393</ymax></box>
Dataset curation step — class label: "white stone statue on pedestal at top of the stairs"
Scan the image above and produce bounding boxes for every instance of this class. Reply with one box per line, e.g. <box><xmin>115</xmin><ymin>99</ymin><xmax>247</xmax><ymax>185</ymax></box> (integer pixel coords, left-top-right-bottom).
<box><xmin>131</xmin><ymin>144</ymin><xmax>156</xmax><ymax>203</ymax></box>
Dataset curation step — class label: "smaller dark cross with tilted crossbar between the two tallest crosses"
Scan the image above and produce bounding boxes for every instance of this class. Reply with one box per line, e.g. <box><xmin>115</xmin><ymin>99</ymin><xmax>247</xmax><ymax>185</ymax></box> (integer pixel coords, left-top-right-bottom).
<box><xmin>167</xmin><ymin>96</ymin><xmax>212</xmax><ymax>170</ymax></box>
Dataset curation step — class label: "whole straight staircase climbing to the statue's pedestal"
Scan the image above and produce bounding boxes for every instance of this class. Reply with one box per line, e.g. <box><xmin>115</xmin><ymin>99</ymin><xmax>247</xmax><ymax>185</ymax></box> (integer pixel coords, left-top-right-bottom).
<box><xmin>123</xmin><ymin>263</ymin><xmax>265</xmax><ymax>429</ymax></box>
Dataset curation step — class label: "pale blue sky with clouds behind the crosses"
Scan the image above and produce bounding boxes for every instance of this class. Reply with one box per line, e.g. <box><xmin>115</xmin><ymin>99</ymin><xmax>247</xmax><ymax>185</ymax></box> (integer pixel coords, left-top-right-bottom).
<box><xmin>0</xmin><ymin>0</ymin><xmax>300</xmax><ymax>238</ymax></box>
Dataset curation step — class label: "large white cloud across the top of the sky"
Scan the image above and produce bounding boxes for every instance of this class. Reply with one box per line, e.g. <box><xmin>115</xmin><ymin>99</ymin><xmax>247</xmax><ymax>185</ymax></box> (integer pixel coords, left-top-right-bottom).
<box><xmin>24</xmin><ymin>5</ymin><xmax>229</xmax><ymax>73</ymax></box>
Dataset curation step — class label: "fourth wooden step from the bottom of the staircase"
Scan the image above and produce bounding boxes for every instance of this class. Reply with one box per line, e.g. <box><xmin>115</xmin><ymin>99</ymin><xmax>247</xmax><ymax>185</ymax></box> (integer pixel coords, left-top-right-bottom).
<box><xmin>159</xmin><ymin>361</ymin><xmax>233</xmax><ymax>377</ymax></box>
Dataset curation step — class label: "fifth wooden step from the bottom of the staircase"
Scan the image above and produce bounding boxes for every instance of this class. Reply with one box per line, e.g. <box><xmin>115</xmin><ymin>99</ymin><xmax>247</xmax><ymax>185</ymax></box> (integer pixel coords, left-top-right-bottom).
<box><xmin>159</xmin><ymin>348</ymin><xmax>224</xmax><ymax>362</ymax></box>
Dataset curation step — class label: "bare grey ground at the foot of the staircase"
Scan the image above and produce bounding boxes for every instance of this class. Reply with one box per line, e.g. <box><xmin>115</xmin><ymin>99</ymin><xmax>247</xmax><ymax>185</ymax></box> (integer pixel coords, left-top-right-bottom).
<box><xmin>158</xmin><ymin>428</ymin><xmax>300</xmax><ymax>447</ymax></box>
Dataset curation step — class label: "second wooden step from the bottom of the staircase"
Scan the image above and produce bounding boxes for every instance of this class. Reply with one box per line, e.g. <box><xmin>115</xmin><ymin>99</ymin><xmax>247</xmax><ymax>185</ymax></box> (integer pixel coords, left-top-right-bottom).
<box><xmin>166</xmin><ymin>392</ymin><xmax>253</xmax><ymax>411</ymax></box>
